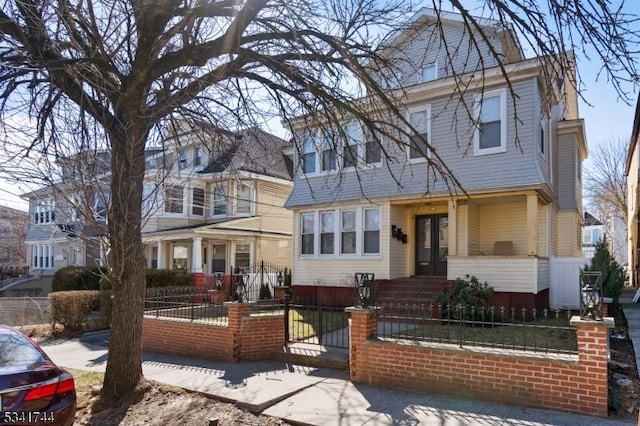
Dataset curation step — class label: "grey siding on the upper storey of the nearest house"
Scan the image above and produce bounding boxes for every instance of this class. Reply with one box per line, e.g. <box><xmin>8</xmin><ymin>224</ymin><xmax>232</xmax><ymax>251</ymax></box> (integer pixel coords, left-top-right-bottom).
<box><xmin>287</xmin><ymin>80</ymin><xmax>544</xmax><ymax>207</ymax></box>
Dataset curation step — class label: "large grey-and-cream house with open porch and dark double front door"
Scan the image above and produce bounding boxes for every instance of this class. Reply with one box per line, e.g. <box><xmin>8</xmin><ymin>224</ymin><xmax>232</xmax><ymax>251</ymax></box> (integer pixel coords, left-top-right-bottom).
<box><xmin>287</xmin><ymin>9</ymin><xmax>587</xmax><ymax>306</ymax></box>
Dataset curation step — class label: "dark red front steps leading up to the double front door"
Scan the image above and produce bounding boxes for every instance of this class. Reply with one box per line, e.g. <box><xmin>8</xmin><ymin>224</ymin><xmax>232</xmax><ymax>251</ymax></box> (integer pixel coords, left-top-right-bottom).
<box><xmin>375</xmin><ymin>276</ymin><xmax>447</xmax><ymax>305</ymax></box>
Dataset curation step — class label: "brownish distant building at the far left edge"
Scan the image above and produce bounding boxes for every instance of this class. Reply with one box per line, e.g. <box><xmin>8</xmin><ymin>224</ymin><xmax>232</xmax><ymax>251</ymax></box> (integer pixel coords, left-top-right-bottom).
<box><xmin>0</xmin><ymin>206</ymin><xmax>29</xmax><ymax>279</ymax></box>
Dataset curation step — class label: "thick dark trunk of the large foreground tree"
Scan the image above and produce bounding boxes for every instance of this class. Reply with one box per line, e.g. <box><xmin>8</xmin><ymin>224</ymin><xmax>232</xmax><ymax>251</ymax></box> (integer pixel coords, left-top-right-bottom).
<box><xmin>101</xmin><ymin>122</ymin><xmax>147</xmax><ymax>402</ymax></box>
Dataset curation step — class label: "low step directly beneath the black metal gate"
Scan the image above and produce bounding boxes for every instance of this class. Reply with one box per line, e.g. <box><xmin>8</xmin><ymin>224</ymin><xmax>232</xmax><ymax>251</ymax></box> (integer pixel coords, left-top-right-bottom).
<box><xmin>270</xmin><ymin>343</ymin><xmax>349</xmax><ymax>370</ymax></box>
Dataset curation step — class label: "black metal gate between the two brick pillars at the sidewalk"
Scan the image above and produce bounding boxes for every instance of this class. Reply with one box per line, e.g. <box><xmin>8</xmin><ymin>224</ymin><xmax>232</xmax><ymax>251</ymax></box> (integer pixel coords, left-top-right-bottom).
<box><xmin>284</xmin><ymin>297</ymin><xmax>349</xmax><ymax>349</ymax></box>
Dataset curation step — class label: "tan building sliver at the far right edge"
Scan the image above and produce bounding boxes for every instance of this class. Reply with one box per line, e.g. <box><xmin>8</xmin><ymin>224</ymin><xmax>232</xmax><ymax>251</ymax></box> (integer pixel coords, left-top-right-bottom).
<box><xmin>625</xmin><ymin>96</ymin><xmax>640</xmax><ymax>287</ymax></box>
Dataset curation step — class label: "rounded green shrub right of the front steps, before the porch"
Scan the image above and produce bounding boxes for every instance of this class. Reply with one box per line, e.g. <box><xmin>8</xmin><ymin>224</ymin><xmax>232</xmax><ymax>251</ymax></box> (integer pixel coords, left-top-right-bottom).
<box><xmin>434</xmin><ymin>275</ymin><xmax>493</xmax><ymax>315</ymax></box>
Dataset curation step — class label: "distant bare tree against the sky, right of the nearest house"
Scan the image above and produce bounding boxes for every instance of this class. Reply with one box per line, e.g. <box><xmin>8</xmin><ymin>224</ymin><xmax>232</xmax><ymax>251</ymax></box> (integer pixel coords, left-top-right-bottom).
<box><xmin>584</xmin><ymin>138</ymin><xmax>628</xmax><ymax>226</ymax></box>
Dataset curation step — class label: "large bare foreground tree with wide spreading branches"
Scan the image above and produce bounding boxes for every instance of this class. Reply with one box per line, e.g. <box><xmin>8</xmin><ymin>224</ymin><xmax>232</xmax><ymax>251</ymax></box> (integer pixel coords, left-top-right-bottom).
<box><xmin>0</xmin><ymin>0</ymin><xmax>638</xmax><ymax>406</ymax></box>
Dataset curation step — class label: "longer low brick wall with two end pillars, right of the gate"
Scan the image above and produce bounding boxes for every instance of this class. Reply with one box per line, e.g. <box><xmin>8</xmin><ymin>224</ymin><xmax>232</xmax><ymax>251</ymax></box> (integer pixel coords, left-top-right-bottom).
<box><xmin>347</xmin><ymin>308</ymin><xmax>614</xmax><ymax>417</ymax></box>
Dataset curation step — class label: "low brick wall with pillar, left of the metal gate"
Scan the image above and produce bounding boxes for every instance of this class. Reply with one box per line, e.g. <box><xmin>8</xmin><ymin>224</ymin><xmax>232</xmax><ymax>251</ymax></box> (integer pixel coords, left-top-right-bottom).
<box><xmin>142</xmin><ymin>302</ymin><xmax>284</xmax><ymax>362</ymax></box>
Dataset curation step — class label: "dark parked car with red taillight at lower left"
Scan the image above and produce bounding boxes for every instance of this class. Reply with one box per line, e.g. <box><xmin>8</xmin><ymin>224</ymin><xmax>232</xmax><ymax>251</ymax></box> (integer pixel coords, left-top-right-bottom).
<box><xmin>0</xmin><ymin>325</ymin><xmax>76</xmax><ymax>425</ymax></box>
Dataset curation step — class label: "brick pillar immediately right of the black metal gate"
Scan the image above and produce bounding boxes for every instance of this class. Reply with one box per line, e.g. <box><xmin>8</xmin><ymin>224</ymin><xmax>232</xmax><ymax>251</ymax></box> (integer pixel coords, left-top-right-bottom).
<box><xmin>345</xmin><ymin>307</ymin><xmax>378</xmax><ymax>383</ymax></box>
